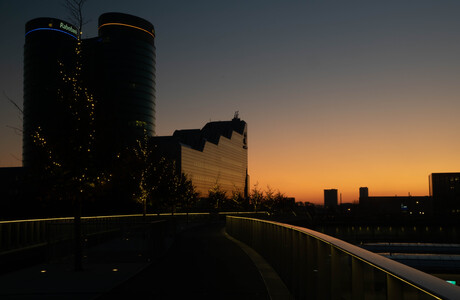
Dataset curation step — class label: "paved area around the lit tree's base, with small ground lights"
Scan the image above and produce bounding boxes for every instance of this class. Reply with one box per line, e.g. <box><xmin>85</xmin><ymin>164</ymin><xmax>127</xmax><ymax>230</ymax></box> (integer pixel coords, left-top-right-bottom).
<box><xmin>0</xmin><ymin>226</ymin><xmax>156</xmax><ymax>300</ymax></box>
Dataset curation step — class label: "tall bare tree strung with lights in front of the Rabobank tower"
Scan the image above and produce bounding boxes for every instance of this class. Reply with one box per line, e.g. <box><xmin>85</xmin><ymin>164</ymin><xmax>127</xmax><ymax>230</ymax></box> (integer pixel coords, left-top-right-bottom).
<box><xmin>33</xmin><ymin>0</ymin><xmax>111</xmax><ymax>270</ymax></box>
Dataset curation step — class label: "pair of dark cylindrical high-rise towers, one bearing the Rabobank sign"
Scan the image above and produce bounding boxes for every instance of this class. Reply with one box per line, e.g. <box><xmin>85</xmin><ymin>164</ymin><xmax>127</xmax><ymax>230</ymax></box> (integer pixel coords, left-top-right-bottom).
<box><xmin>23</xmin><ymin>13</ymin><xmax>155</xmax><ymax>167</ymax></box>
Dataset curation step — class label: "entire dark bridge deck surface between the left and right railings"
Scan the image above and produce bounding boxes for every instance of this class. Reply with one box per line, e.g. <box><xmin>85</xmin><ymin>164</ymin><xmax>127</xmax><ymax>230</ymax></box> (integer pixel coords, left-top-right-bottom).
<box><xmin>0</xmin><ymin>223</ymin><xmax>286</xmax><ymax>300</ymax></box>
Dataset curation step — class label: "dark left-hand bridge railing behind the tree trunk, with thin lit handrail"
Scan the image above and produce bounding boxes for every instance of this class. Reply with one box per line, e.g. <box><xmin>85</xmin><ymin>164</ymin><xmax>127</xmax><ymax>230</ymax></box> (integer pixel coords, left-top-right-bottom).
<box><xmin>0</xmin><ymin>215</ymin><xmax>173</xmax><ymax>274</ymax></box>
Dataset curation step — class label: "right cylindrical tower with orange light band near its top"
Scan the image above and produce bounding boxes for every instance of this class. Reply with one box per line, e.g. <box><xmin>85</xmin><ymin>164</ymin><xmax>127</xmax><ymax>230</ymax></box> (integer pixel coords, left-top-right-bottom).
<box><xmin>97</xmin><ymin>13</ymin><xmax>155</xmax><ymax>154</ymax></box>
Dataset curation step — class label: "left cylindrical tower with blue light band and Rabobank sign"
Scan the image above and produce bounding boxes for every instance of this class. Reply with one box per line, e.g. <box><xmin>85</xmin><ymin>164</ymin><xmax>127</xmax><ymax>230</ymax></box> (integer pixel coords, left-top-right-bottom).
<box><xmin>23</xmin><ymin>18</ymin><xmax>77</xmax><ymax>167</ymax></box>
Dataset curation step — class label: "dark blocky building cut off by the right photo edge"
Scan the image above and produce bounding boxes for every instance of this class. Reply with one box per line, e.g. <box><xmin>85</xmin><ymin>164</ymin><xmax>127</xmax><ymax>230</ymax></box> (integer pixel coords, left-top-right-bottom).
<box><xmin>428</xmin><ymin>173</ymin><xmax>460</xmax><ymax>216</ymax></box>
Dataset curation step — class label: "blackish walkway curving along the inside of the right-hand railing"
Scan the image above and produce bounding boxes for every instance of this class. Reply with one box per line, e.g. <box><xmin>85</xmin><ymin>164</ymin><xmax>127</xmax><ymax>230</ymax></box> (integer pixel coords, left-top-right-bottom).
<box><xmin>98</xmin><ymin>223</ymin><xmax>269</xmax><ymax>300</ymax></box>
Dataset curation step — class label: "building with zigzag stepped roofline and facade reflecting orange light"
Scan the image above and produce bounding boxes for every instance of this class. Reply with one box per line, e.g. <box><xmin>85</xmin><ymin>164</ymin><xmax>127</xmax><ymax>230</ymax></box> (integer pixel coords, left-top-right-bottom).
<box><xmin>152</xmin><ymin>116</ymin><xmax>249</xmax><ymax>197</ymax></box>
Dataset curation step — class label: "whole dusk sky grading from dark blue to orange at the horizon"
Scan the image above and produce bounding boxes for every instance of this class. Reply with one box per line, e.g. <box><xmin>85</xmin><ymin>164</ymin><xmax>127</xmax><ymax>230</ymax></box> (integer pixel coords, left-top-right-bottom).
<box><xmin>0</xmin><ymin>0</ymin><xmax>460</xmax><ymax>203</ymax></box>
